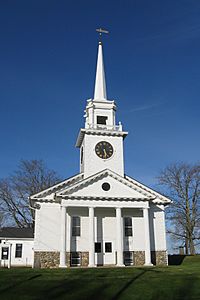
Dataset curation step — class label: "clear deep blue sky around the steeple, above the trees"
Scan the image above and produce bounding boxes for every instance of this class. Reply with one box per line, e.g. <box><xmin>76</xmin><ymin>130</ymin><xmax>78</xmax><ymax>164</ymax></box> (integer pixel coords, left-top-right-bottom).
<box><xmin>0</xmin><ymin>0</ymin><xmax>200</xmax><ymax>187</ymax></box>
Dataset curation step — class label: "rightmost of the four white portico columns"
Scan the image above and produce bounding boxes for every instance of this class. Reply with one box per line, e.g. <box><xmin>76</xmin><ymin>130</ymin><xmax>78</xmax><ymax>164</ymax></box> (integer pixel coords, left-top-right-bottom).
<box><xmin>143</xmin><ymin>208</ymin><xmax>152</xmax><ymax>266</ymax></box>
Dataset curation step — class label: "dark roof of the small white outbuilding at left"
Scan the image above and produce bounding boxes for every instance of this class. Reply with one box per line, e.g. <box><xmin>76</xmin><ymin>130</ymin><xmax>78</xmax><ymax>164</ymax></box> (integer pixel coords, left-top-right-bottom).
<box><xmin>0</xmin><ymin>227</ymin><xmax>34</xmax><ymax>239</ymax></box>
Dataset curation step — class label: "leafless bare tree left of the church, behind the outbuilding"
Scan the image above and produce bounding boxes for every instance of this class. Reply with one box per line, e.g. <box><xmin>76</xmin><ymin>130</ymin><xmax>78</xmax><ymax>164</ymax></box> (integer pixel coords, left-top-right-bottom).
<box><xmin>0</xmin><ymin>160</ymin><xmax>60</xmax><ymax>227</ymax></box>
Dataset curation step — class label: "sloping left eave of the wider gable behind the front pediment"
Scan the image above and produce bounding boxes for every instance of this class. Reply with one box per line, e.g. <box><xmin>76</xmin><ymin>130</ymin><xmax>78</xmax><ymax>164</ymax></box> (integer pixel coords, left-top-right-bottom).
<box><xmin>30</xmin><ymin>173</ymin><xmax>83</xmax><ymax>200</ymax></box>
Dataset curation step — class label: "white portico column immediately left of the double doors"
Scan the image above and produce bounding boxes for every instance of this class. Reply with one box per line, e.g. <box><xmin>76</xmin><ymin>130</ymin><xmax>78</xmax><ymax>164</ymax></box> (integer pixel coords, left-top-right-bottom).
<box><xmin>88</xmin><ymin>207</ymin><xmax>95</xmax><ymax>267</ymax></box>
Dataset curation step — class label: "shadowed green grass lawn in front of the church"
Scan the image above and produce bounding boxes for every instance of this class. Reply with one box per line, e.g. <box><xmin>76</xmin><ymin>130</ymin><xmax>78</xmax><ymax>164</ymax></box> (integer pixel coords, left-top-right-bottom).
<box><xmin>0</xmin><ymin>255</ymin><xmax>200</xmax><ymax>300</ymax></box>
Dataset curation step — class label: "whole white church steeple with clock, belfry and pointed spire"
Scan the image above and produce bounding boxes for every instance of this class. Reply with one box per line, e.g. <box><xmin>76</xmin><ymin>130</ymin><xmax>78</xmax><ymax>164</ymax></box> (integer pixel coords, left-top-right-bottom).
<box><xmin>76</xmin><ymin>38</ymin><xmax>128</xmax><ymax>178</ymax></box>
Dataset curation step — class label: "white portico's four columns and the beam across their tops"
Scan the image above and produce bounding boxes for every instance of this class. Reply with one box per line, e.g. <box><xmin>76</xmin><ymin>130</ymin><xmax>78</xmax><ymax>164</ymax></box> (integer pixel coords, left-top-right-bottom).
<box><xmin>60</xmin><ymin>200</ymin><xmax>152</xmax><ymax>268</ymax></box>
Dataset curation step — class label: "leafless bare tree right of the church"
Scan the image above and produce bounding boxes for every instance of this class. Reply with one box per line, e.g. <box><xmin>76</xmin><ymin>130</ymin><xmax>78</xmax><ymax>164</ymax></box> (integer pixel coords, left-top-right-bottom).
<box><xmin>158</xmin><ymin>163</ymin><xmax>200</xmax><ymax>254</ymax></box>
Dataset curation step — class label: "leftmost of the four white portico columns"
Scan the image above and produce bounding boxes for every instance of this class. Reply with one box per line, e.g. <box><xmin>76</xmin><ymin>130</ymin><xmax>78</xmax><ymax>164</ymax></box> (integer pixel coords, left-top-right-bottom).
<box><xmin>59</xmin><ymin>206</ymin><xmax>67</xmax><ymax>268</ymax></box>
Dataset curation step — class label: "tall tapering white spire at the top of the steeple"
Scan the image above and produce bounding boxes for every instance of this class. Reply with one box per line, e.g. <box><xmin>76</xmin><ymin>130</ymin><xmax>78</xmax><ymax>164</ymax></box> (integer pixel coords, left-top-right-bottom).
<box><xmin>94</xmin><ymin>42</ymin><xmax>107</xmax><ymax>100</ymax></box>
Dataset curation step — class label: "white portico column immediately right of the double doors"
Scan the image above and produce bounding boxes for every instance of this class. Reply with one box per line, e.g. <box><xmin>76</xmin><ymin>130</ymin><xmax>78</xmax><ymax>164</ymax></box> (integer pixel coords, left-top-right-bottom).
<box><xmin>116</xmin><ymin>207</ymin><xmax>124</xmax><ymax>267</ymax></box>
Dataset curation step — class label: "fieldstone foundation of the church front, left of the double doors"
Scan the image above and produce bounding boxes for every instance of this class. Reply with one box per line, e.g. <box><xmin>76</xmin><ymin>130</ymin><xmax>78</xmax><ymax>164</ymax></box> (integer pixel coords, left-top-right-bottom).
<box><xmin>34</xmin><ymin>251</ymin><xmax>89</xmax><ymax>268</ymax></box>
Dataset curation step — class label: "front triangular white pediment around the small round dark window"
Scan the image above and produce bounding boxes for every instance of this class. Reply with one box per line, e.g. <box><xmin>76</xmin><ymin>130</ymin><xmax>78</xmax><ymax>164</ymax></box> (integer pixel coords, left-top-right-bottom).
<box><xmin>57</xmin><ymin>169</ymin><xmax>155</xmax><ymax>200</ymax></box>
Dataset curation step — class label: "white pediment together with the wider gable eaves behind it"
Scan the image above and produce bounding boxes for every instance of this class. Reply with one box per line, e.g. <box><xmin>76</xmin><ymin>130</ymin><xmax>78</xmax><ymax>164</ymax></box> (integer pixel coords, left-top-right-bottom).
<box><xmin>30</xmin><ymin>169</ymin><xmax>171</xmax><ymax>204</ymax></box>
